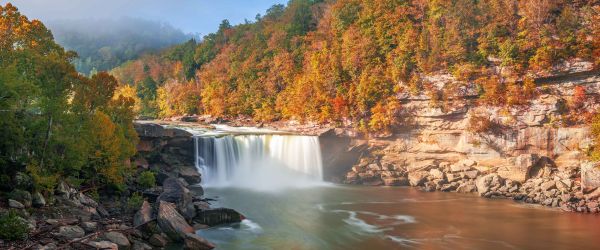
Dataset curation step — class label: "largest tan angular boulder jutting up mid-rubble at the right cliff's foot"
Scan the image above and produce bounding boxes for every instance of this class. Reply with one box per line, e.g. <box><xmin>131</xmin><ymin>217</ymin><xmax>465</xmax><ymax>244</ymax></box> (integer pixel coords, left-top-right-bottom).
<box><xmin>497</xmin><ymin>154</ymin><xmax>540</xmax><ymax>183</ymax></box>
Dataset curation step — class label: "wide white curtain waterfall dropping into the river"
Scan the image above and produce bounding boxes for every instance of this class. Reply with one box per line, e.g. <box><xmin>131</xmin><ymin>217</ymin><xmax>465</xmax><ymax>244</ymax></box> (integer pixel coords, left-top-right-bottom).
<box><xmin>194</xmin><ymin>134</ymin><xmax>323</xmax><ymax>188</ymax></box>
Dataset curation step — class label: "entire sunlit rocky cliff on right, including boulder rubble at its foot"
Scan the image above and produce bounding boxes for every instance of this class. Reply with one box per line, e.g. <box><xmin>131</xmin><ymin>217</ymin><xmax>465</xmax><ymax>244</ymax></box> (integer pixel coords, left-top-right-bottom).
<box><xmin>332</xmin><ymin>71</ymin><xmax>600</xmax><ymax>211</ymax></box>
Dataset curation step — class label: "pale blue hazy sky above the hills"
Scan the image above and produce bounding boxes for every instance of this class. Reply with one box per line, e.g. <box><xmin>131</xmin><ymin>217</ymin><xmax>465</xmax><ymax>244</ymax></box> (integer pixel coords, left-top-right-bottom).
<box><xmin>0</xmin><ymin>0</ymin><xmax>287</xmax><ymax>35</ymax></box>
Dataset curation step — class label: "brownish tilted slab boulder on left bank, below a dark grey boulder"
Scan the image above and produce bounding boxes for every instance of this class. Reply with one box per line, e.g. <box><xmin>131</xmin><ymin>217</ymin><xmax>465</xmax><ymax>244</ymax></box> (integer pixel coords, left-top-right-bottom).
<box><xmin>157</xmin><ymin>201</ymin><xmax>194</xmax><ymax>242</ymax></box>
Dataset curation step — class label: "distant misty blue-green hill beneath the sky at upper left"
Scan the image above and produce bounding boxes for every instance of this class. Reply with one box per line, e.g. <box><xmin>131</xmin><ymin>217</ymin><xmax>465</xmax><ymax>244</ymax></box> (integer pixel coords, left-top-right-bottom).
<box><xmin>48</xmin><ymin>18</ymin><xmax>192</xmax><ymax>75</ymax></box>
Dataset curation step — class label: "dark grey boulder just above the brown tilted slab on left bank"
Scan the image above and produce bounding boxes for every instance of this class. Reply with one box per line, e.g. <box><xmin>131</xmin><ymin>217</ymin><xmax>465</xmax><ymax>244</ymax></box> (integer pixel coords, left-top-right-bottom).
<box><xmin>156</xmin><ymin>178</ymin><xmax>196</xmax><ymax>220</ymax></box>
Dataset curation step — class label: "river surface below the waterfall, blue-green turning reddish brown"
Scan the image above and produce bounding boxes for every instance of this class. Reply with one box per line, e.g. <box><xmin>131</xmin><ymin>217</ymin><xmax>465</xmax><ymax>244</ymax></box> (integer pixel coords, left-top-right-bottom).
<box><xmin>198</xmin><ymin>185</ymin><xmax>600</xmax><ymax>249</ymax></box>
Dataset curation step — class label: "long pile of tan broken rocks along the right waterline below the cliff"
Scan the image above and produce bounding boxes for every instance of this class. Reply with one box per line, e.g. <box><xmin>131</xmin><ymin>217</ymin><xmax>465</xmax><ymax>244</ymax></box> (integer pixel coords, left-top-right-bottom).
<box><xmin>344</xmin><ymin>154</ymin><xmax>600</xmax><ymax>213</ymax></box>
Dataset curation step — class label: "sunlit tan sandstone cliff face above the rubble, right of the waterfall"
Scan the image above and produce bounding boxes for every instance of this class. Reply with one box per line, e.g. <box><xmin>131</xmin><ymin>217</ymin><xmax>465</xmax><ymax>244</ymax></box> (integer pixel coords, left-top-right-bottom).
<box><xmin>345</xmin><ymin>71</ymin><xmax>600</xmax><ymax>195</ymax></box>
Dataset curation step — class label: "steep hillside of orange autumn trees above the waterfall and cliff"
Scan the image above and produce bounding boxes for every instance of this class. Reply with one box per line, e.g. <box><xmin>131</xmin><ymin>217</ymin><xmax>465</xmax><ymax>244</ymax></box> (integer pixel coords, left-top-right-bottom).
<box><xmin>113</xmin><ymin>0</ymin><xmax>600</xmax><ymax>131</ymax></box>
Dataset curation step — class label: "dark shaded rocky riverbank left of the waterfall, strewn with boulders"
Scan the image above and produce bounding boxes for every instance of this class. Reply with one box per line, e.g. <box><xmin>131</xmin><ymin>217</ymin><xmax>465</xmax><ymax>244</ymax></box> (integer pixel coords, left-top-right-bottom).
<box><xmin>0</xmin><ymin>124</ymin><xmax>244</xmax><ymax>250</ymax></box>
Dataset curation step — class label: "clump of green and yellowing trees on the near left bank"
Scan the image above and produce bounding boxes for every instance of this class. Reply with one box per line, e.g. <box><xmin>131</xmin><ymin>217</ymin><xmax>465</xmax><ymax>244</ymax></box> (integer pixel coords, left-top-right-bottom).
<box><xmin>0</xmin><ymin>3</ymin><xmax>137</xmax><ymax>194</ymax></box>
